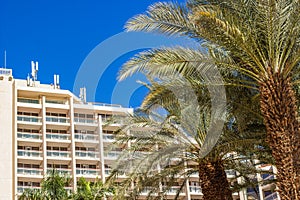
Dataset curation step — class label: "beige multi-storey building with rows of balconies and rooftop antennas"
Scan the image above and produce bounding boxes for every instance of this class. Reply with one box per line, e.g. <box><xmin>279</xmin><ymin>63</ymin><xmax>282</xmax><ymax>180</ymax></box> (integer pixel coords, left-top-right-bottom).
<box><xmin>0</xmin><ymin>68</ymin><xmax>278</xmax><ymax>200</ymax></box>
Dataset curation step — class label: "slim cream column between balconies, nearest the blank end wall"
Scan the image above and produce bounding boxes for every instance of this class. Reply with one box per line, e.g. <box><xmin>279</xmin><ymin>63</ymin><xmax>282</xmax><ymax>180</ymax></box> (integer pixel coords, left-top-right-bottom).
<box><xmin>41</xmin><ymin>96</ymin><xmax>47</xmax><ymax>176</ymax></box>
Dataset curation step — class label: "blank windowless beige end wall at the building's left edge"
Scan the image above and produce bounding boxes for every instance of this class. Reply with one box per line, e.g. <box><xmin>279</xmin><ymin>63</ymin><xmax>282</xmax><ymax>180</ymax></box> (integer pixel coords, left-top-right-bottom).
<box><xmin>0</xmin><ymin>72</ymin><xmax>14</xmax><ymax>200</ymax></box>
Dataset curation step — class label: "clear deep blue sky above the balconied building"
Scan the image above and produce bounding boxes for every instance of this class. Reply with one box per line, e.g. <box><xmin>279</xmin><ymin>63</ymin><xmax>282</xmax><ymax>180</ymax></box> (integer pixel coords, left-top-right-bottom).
<box><xmin>0</xmin><ymin>0</ymin><xmax>183</xmax><ymax>107</ymax></box>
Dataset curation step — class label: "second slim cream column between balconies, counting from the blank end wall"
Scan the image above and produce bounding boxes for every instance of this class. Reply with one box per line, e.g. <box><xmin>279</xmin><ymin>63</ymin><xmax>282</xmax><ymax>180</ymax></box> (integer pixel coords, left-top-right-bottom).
<box><xmin>69</xmin><ymin>97</ymin><xmax>77</xmax><ymax>191</ymax></box>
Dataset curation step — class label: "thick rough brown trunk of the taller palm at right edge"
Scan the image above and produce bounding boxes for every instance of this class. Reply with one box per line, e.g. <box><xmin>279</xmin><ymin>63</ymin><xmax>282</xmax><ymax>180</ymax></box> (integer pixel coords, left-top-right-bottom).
<box><xmin>260</xmin><ymin>72</ymin><xmax>300</xmax><ymax>200</ymax></box>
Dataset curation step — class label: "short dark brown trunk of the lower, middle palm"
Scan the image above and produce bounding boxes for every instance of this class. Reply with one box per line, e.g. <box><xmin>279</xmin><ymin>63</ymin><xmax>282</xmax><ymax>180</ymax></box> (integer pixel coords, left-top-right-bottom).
<box><xmin>199</xmin><ymin>159</ymin><xmax>232</xmax><ymax>200</ymax></box>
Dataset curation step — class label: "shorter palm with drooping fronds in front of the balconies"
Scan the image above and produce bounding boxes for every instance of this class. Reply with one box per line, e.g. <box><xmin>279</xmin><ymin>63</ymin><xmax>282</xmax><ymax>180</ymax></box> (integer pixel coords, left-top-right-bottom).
<box><xmin>106</xmin><ymin>79</ymin><xmax>270</xmax><ymax>200</ymax></box>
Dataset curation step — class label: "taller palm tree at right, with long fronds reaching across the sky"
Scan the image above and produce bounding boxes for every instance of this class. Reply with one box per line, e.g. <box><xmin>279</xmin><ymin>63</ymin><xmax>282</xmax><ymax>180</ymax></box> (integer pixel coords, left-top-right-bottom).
<box><xmin>120</xmin><ymin>0</ymin><xmax>300</xmax><ymax>199</ymax></box>
